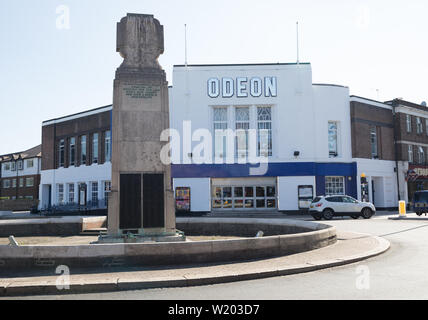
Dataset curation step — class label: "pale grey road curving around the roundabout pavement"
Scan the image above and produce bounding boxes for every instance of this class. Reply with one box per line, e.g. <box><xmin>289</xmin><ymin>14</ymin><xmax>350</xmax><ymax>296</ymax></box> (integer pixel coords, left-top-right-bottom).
<box><xmin>5</xmin><ymin>215</ymin><xmax>428</xmax><ymax>300</ymax></box>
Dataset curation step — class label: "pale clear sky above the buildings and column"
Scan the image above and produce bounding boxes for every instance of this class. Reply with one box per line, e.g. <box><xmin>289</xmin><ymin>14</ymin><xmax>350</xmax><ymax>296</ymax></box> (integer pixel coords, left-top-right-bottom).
<box><xmin>0</xmin><ymin>0</ymin><xmax>428</xmax><ymax>154</ymax></box>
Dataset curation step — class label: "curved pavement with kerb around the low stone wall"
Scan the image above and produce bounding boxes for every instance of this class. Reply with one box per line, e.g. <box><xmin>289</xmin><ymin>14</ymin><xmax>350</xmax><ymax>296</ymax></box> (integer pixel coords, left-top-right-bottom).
<box><xmin>0</xmin><ymin>230</ymin><xmax>390</xmax><ymax>297</ymax></box>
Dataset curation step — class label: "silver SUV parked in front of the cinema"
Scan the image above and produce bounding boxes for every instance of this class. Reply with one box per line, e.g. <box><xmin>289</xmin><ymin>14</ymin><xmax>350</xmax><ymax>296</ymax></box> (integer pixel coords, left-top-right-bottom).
<box><xmin>309</xmin><ymin>195</ymin><xmax>376</xmax><ymax>220</ymax></box>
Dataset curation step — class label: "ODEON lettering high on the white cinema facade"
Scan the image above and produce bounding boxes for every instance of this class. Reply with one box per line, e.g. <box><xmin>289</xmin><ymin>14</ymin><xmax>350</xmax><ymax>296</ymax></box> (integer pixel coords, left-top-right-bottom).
<box><xmin>207</xmin><ymin>77</ymin><xmax>278</xmax><ymax>98</ymax></box>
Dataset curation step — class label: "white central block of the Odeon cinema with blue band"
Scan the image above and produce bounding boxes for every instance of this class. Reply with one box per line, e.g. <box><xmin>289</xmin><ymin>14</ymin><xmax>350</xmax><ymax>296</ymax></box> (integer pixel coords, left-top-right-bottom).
<box><xmin>170</xmin><ymin>63</ymin><xmax>358</xmax><ymax>212</ymax></box>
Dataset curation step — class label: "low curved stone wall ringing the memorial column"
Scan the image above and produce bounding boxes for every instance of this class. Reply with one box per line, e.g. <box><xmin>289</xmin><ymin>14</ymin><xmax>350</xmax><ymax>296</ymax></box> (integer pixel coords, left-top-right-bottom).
<box><xmin>0</xmin><ymin>218</ymin><xmax>337</xmax><ymax>271</ymax></box>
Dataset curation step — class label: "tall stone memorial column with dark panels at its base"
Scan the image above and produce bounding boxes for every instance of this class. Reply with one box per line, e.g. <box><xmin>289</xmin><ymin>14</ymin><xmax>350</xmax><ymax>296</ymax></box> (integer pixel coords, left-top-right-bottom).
<box><xmin>100</xmin><ymin>14</ymin><xmax>183</xmax><ymax>242</ymax></box>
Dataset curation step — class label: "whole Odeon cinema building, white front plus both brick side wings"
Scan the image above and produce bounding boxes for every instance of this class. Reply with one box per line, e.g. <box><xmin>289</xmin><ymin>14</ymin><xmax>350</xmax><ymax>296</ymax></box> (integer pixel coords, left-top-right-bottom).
<box><xmin>40</xmin><ymin>63</ymin><xmax>404</xmax><ymax>213</ymax></box>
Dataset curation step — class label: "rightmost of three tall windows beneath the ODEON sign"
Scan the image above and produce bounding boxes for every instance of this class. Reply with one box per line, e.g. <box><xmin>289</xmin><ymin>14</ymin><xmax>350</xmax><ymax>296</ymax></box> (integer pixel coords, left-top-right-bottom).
<box><xmin>257</xmin><ymin>107</ymin><xmax>272</xmax><ymax>157</ymax></box>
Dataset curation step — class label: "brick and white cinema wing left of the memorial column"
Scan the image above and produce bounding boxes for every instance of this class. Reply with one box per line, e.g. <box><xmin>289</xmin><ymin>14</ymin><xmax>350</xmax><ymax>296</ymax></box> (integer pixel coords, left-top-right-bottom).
<box><xmin>39</xmin><ymin>105</ymin><xmax>112</xmax><ymax>210</ymax></box>
